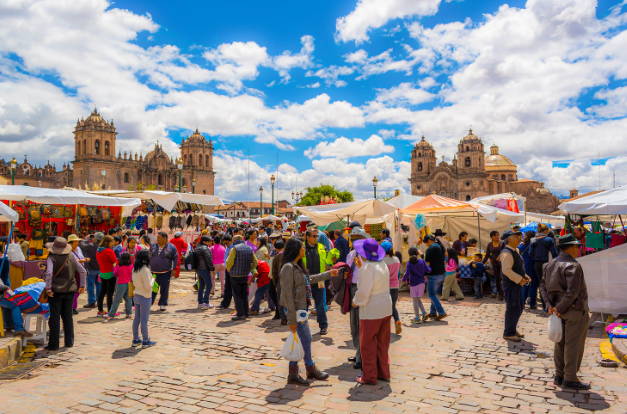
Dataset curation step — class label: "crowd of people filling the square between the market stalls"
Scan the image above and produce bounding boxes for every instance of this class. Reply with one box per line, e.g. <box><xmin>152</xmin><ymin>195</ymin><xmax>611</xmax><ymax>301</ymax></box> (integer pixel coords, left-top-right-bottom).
<box><xmin>0</xmin><ymin>218</ymin><xmax>589</xmax><ymax>389</ymax></box>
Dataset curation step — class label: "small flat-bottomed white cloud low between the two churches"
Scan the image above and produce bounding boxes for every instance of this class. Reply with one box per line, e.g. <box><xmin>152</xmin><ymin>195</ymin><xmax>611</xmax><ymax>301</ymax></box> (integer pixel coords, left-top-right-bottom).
<box><xmin>305</xmin><ymin>135</ymin><xmax>394</xmax><ymax>159</ymax></box>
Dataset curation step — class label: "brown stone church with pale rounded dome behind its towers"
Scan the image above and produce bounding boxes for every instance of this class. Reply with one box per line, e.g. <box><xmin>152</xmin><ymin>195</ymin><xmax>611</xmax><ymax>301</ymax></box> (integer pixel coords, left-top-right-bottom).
<box><xmin>409</xmin><ymin>129</ymin><xmax>558</xmax><ymax>214</ymax></box>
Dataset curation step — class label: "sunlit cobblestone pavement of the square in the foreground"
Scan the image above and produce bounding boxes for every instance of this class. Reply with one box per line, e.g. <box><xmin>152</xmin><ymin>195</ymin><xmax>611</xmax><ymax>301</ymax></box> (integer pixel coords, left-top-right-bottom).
<box><xmin>0</xmin><ymin>274</ymin><xmax>627</xmax><ymax>414</ymax></box>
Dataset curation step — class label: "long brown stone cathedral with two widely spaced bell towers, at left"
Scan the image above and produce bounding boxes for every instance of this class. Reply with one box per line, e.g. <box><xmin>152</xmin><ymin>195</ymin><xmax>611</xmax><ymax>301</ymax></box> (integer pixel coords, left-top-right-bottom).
<box><xmin>0</xmin><ymin>110</ymin><xmax>215</xmax><ymax>195</ymax></box>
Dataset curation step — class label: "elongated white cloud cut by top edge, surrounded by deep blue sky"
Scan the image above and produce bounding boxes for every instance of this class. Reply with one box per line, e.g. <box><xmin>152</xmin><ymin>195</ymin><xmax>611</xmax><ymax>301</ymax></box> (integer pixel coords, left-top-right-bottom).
<box><xmin>335</xmin><ymin>0</ymin><xmax>440</xmax><ymax>44</ymax></box>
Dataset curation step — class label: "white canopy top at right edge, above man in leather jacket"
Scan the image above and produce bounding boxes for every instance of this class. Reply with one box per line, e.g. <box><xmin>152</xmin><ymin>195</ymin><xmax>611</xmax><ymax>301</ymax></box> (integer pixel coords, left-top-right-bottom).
<box><xmin>559</xmin><ymin>186</ymin><xmax>627</xmax><ymax>216</ymax></box>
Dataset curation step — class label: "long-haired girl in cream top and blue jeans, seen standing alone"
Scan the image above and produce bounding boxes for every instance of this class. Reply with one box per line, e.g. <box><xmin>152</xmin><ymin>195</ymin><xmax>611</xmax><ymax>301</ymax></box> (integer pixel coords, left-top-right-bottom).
<box><xmin>132</xmin><ymin>249</ymin><xmax>157</xmax><ymax>348</ymax></box>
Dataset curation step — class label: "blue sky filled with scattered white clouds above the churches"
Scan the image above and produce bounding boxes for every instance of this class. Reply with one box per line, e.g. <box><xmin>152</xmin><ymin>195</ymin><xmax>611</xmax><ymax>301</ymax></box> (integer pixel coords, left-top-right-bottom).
<box><xmin>0</xmin><ymin>0</ymin><xmax>627</xmax><ymax>201</ymax></box>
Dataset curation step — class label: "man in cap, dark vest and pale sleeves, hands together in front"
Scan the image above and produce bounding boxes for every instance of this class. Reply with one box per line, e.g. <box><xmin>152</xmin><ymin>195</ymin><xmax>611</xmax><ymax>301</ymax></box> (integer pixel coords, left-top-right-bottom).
<box><xmin>499</xmin><ymin>230</ymin><xmax>531</xmax><ymax>342</ymax></box>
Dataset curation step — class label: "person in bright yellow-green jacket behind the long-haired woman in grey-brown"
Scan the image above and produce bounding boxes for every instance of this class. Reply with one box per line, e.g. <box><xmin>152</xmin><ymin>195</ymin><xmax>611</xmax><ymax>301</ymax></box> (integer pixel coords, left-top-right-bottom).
<box><xmin>303</xmin><ymin>223</ymin><xmax>329</xmax><ymax>335</ymax></box>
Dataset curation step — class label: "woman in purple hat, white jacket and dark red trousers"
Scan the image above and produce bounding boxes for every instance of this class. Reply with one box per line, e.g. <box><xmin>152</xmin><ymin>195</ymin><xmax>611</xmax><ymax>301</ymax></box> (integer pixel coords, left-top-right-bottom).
<box><xmin>353</xmin><ymin>239</ymin><xmax>392</xmax><ymax>384</ymax></box>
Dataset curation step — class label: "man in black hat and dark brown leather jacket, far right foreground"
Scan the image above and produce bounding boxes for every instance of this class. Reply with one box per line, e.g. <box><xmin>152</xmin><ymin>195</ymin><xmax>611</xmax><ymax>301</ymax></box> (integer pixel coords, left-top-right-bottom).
<box><xmin>540</xmin><ymin>234</ymin><xmax>590</xmax><ymax>390</ymax></box>
